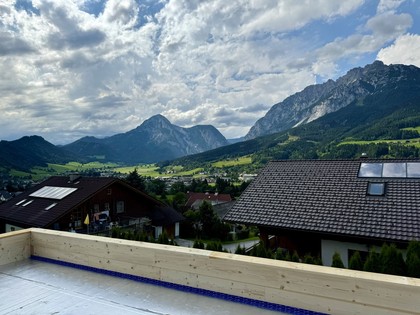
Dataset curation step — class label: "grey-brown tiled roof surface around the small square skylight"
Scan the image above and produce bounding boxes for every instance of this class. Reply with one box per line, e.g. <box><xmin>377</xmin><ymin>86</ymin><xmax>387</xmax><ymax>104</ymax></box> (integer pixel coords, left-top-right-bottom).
<box><xmin>224</xmin><ymin>159</ymin><xmax>420</xmax><ymax>241</ymax></box>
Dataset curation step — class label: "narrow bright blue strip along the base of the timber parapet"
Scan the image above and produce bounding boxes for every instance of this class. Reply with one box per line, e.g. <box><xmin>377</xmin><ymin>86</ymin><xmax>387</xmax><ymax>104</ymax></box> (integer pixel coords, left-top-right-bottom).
<box><xmin>31</xmin><ymin>255</ymin><xmax>326</xmax><ymax>315</ymax></box>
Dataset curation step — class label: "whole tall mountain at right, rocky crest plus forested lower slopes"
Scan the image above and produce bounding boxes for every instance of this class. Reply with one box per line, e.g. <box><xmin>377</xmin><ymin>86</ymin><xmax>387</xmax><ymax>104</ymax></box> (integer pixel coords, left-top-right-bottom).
<box><xmin>174</xmin><ymin>62</ymin><xmax>420</xmax><ymax>166</ymax></box>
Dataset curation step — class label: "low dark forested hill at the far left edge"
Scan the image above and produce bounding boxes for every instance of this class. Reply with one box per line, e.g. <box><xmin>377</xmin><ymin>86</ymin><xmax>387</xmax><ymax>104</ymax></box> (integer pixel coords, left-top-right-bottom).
<box><xmin>0</xmin><ymin>136</ymin><xmax>78</xmax><ymax>171</ymax></box>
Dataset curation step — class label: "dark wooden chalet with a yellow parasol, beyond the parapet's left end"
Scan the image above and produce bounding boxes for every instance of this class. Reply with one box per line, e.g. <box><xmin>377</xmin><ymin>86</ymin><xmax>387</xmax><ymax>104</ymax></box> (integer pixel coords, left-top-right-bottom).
<box><xmin>0</xmin><ymin>175</ymin><xmax>183</xmax><ymax>237</ymax></box>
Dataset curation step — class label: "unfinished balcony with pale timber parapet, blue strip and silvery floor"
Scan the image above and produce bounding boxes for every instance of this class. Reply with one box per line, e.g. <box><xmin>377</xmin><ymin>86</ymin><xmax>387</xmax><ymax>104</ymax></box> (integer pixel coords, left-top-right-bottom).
<box><xmin>0</xmin><ymin>228</ymin><xmax>420</xmax><ymax>314</ymax></box>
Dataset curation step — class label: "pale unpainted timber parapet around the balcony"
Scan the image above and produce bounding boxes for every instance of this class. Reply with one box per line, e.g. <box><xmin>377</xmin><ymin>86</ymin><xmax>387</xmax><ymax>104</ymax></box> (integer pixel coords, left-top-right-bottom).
<box><xmin>0</xmin><ymin>229</ymin><xmax>420</xmax><ymax>314</ymax></box>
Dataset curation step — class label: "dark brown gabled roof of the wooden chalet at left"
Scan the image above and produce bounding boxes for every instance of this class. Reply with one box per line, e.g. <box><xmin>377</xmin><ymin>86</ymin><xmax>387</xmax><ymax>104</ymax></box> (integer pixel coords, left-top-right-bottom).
<box><xmin>0</xmin><ymin>176</ymin><xmax>160</xmax><ymax>227</ymax></box>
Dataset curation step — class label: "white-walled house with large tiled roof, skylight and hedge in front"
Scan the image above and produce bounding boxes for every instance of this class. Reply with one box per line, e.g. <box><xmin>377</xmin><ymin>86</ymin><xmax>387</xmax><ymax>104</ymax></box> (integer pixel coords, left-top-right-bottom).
<box><xmin>224</xmin><ymin>158</ymin><xmax>420</xmax><ymax>266</ymax></box>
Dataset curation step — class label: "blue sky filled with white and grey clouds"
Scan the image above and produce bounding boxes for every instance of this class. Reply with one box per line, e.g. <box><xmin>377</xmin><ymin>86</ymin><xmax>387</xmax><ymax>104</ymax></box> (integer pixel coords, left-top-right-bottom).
<box><xmin>0</xmin><ymin>0</ymin><xmax>420</xmax><ymax>144</ymax></box>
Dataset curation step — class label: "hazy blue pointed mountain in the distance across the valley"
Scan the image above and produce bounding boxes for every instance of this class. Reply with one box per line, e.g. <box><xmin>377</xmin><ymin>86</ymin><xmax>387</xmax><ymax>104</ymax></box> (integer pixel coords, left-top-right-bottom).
<box><xmin>64</xmin><ymin>115</ymin><xmax>228</xmax><ymax>163</ymax></box>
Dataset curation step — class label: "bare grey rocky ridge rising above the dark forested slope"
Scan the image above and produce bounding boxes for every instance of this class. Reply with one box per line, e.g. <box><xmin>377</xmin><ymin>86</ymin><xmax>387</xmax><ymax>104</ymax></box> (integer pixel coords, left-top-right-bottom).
<box><xmin>245</xmin><ymin>61</ymin><xmax>420</xmax><ymax>140</ymax></box>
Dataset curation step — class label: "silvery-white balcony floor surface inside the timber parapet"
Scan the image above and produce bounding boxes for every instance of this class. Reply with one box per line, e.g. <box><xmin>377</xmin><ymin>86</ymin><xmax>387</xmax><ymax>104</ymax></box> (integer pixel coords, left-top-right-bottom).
<box><xmin>0</xmin><ymin>259</ymin><xmax>292</xmax><ymax>315</ymax></box>
